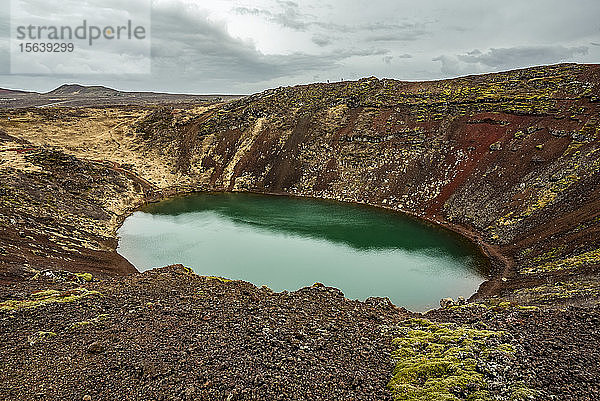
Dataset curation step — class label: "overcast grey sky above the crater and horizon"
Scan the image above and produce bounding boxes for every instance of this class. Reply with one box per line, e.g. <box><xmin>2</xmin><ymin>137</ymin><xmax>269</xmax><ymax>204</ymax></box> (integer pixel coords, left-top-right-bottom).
<box><xmin>0</xmin><ymin>0</ymin><xmax>600</xmax><ymax>93</ymax></box>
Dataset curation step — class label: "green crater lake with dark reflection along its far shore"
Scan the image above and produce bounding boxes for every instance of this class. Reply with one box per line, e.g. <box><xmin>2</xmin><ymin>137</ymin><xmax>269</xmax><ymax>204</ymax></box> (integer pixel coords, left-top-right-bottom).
<box><xmin>118</xmin><ymin>193</ymin><xmax>485</xmax><ymax>310</ymax></box>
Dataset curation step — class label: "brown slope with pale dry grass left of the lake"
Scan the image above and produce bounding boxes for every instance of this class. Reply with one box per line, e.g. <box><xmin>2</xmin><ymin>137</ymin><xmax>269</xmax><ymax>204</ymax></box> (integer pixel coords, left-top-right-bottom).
<box><xmin>0</xmin><ymin>134</ymin><xmax>143</xmax><ymax>284</ymax></box>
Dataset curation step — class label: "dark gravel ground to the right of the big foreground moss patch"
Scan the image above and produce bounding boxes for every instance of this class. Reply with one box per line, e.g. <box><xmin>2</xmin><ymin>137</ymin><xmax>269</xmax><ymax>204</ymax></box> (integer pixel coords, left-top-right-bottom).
<box><xmin>426</xmin><ymin>306</ymin><xmax>600</xmax><ymax>400</ymax></box>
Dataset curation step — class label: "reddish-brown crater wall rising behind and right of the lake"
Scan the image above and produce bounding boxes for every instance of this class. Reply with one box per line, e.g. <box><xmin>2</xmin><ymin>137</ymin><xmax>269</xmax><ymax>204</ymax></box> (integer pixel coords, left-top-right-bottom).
<box><xmin>154</xmin><ymin>65</ymin><xmax>600</xmax><ymax>304</ymax></box>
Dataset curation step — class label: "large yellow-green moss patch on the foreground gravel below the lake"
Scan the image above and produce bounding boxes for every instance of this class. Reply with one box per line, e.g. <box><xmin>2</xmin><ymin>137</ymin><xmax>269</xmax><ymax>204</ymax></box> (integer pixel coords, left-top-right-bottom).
<box><xmin>388</xmin><ymin>319</ymin><xmax>512</xmax><ymax>401</ymax></box>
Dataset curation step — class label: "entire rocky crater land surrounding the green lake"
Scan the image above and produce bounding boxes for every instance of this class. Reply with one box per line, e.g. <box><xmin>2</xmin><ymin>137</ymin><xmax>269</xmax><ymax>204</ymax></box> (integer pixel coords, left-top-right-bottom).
<box><xmin>0</xmin><ymin>65</ymin><xmax>600</xmax><ymax>400</ymax></box>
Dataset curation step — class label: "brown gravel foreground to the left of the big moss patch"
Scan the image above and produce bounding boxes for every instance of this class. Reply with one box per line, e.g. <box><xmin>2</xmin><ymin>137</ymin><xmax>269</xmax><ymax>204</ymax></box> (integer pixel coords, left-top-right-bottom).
<box><xmin>0</xmin><ymin>267</ymin><xmax>406</xmax><ymax>400</ymax></box>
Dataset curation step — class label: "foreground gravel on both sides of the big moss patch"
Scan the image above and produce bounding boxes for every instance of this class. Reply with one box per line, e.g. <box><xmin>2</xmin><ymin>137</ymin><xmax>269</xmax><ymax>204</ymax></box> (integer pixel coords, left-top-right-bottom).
<box><xmin>0</xmin><ymin>265</ymin><xmax>600</xmax><ymax>401</ymax></box>
